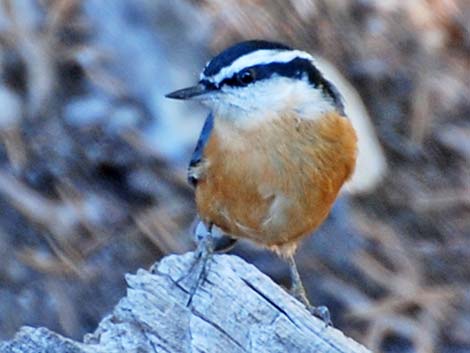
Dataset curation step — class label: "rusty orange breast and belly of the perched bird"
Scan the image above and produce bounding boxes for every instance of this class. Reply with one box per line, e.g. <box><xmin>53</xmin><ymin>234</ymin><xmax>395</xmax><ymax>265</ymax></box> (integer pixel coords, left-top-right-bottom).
<box><xmin>196</xmin><ymin>113</ymin><xmax>356</xmax><ymax>253</ymax></box>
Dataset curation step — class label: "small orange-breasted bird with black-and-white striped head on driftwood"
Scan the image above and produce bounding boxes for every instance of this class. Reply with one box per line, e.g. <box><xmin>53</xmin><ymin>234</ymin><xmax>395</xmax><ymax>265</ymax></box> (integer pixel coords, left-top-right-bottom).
<box><xmin>166</xmin><ymin>40</ymin><xmax>357</xmax><ymax>324</ymax></box>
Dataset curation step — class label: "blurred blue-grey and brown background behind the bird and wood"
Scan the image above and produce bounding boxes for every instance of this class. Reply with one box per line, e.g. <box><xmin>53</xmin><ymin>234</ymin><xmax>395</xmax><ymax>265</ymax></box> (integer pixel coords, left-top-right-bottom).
<box><xmin>0</xmin><ymin>0</ymin><xmax>470</xmax><ymax>353</ymax></box>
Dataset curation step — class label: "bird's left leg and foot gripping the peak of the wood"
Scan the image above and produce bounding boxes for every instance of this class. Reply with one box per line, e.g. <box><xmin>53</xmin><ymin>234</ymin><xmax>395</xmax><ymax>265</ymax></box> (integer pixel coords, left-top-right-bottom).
<box><xmin>186</xmin><ymin>223</ymin><xmax>214</xmax><ymax>306</ymax></box>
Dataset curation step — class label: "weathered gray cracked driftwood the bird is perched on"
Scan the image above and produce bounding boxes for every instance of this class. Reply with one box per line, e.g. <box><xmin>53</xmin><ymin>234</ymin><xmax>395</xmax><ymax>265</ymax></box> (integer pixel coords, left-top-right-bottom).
<box><xmin>0</xmin><ymin>253</ymin><xmax>370</xmax><ymax>353</ymax></box>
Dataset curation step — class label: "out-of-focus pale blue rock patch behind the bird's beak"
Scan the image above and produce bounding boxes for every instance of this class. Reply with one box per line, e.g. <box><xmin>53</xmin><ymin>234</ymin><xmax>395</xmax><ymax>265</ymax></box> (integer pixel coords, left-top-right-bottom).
<box><xmin>85</xmin><ymin>0</ymin><xmax>209</xmax><ymax>161</ymax></box>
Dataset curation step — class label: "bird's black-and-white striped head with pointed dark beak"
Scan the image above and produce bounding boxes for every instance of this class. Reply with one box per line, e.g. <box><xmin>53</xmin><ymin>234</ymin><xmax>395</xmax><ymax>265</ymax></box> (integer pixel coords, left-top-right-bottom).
<box><xmin>167</xmin><ymin>40</ymin><xmax>343</xmax><ymax>125</ymax></box>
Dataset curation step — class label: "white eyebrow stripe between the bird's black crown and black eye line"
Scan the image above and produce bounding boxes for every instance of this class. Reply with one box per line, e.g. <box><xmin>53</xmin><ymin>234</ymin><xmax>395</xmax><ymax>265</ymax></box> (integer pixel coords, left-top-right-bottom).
<box><xmin>201</xmin><ymin>49</ymin><xmax>313</xmax><ymax>83</ymax></box>
